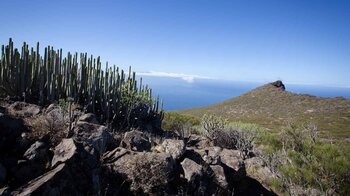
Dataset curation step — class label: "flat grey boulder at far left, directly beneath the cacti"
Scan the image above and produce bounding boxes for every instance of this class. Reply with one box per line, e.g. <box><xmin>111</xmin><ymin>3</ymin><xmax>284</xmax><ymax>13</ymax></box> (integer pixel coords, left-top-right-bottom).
<box><xmin>8</xmin><ymin>102</ymin><xmax>41</xmax><ymax>117</ymax></box>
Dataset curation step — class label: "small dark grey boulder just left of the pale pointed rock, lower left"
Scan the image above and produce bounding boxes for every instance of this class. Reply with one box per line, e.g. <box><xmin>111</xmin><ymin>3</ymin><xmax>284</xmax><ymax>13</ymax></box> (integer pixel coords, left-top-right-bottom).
<box><xmin>23</xmin><ymin>141</ymin><xmax>48</xmax><ymax>162</ymax></box>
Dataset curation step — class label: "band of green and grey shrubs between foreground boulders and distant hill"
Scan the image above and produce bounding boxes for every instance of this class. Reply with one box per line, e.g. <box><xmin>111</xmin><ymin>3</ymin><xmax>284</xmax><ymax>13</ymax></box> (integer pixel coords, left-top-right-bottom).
<box><xmin>163</xmin><ymin>113</ymin><xmax>350</xmax><ymax>195</ymax></box>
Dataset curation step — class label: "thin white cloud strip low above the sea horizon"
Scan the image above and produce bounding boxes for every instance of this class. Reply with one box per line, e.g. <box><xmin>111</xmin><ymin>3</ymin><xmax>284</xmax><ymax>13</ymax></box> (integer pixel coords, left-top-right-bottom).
<box><xmin>137</xmin><ymin>71</ymin><xmax>212</xmax><ymax>83</ymax></box>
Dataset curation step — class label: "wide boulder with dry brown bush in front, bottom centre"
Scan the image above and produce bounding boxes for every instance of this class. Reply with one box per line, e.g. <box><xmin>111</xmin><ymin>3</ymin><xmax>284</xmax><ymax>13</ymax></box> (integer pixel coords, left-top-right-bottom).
<box><xmin>103</xmin><ymin>147</ymin><xmax>176</xmax><ymax>194</ymax></box>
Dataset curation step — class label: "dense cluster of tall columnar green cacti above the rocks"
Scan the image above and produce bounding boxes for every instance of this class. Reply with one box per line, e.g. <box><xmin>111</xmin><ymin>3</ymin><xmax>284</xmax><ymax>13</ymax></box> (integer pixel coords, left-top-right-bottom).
<box><xmin>0</xmin><ymin>39</ymin><xmax>163</xmax><ymax>129</ymax></box>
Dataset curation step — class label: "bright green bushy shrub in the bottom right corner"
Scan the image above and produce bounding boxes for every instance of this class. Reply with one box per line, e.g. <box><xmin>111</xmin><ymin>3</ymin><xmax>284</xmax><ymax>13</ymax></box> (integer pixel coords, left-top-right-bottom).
<box><xmin>259</xmin><ymin>125</ymin><xmax>350</xmax><ymax>195</ymax></box>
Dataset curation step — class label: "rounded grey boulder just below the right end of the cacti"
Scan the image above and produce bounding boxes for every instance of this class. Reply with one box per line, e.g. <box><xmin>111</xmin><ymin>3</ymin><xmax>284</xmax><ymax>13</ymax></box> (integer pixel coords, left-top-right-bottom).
<box><xmin>120</xmin><ymin>130</ymin><xmax>152</xmax><ymax>152</ymax></box>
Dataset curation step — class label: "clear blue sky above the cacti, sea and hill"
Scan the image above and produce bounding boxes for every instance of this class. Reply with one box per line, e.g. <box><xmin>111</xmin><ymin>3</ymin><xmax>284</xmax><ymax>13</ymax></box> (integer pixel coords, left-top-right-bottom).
<box><xmin>0</xmin><ymin>0</ymin><xmax>350</xmax><ymax>86</ymax></box>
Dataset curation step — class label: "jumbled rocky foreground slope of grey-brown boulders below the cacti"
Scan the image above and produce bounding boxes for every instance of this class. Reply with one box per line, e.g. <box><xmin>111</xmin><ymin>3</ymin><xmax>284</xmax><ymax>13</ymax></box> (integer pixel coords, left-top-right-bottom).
<box><xmin>0</xmin><ymin>100</ymin><xmax>275</xmax><ymax>195</ymax></box>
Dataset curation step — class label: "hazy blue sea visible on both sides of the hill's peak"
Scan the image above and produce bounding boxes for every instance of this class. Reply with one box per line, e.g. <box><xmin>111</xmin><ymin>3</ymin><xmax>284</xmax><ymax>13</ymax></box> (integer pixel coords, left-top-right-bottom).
<box><xmin>142</xmin><ymin>76</ymin><xmax>350</xmax><ymax>111</ymax></box>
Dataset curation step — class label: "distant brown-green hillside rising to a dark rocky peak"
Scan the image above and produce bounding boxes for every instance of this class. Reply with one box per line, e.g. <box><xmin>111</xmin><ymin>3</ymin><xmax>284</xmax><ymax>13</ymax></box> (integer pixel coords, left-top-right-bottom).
<box><xmin>179</xmin><ymin>81</ymin><xmax>350</xmax><ymax>138</ymax></box>
